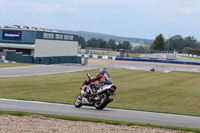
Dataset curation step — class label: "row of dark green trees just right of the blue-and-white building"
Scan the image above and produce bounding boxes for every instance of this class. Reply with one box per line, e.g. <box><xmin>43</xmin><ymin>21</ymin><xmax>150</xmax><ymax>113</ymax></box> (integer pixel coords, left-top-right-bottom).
<box><xmin>78</xmin><ymin>36</ymin><xmax>131</xmax><ymax>50</ymax></box>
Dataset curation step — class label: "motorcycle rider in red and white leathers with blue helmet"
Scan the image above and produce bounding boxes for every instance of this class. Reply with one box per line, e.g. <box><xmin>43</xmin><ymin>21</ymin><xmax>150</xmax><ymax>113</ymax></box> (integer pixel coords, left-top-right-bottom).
<box><xmin>84</xmin><ymin>68</ymin><xmax>112</xmax><ymax>98</ymax></box>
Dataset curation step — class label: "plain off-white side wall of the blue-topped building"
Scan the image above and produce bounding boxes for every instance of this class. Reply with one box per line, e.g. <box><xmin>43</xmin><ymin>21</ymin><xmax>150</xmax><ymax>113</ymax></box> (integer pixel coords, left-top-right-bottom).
<box><xmin>33</xmin><ymin>39</ymin><xmax>78</xmax><ymax>57</ymax></box>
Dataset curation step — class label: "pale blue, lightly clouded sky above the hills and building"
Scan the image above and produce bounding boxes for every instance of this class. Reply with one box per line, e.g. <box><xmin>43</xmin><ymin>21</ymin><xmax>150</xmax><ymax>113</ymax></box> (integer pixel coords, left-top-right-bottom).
<box><xmin>0</xmin><ymin>0</ymin><xmax>200</xmax><ymax>41</ymax></box>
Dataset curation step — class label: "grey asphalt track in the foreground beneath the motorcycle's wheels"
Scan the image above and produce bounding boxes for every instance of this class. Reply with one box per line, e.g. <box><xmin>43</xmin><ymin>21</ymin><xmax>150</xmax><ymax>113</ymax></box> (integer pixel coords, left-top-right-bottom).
<box><xmin>0</xmin><ymin>99</ymin><xmax>200</xmax><ymax>128</ymax></box>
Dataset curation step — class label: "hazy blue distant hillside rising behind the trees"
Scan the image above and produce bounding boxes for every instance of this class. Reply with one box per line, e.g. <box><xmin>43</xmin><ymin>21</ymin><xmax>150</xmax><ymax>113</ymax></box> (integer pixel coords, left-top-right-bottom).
<box><xmin>57</xmin><ymin>30</ymin><xmax>153</xmax><ymax>44</ymax></box>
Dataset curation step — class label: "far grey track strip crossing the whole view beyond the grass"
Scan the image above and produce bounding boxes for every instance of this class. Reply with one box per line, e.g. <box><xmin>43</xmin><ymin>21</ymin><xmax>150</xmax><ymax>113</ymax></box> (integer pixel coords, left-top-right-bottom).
<box><xmin>0</xmin><ymin>59</ymin><xmax>200</xmax><ymax>77</ymax></box>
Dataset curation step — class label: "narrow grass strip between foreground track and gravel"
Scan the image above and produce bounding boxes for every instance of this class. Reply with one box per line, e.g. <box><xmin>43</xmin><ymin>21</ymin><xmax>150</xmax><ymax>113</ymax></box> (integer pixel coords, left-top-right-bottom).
<box><xmin>0</xmin><ymin>111</ymin><xmax>200</xmax><ymax>133</ymax></box>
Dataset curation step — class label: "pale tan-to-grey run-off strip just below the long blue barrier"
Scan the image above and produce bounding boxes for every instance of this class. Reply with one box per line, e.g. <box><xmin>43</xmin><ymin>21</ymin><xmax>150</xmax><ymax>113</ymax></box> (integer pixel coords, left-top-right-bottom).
<box><xmin>88</xmin><ymin>59</ymin><xmax>200</xmax><ymax>73</ymax></box>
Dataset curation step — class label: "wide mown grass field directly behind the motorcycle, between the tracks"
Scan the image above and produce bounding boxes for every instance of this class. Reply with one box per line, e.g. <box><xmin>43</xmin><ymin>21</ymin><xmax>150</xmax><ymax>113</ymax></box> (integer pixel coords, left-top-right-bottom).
<box><xmin>0</xmin><ymin>68</ymin><xmax>200</xmax><ymax>116</ymax></box>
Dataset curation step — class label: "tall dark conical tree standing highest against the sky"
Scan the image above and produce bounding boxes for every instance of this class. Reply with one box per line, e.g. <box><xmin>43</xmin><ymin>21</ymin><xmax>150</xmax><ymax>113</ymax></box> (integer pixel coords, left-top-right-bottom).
<box><xmin>151</xmin><ymin>34</ymin><xmax>165</xmax><ymax>51</ymax></box>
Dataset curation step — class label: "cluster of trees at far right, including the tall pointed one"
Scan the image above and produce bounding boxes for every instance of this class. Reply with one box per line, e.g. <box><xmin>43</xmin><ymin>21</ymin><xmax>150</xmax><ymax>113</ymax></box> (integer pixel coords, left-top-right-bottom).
<box><xmin>150</xmin><ymin>34</ymin><xmax>200</xmax><ymax>55</ymax></box>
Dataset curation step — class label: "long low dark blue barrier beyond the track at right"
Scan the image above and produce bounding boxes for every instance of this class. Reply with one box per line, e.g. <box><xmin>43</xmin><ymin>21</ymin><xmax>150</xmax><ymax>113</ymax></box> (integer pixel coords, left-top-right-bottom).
<box><xmin>115</xmin><ymin>57</ymin><xmax>200</xmax><ymax>65</ymax></box>
